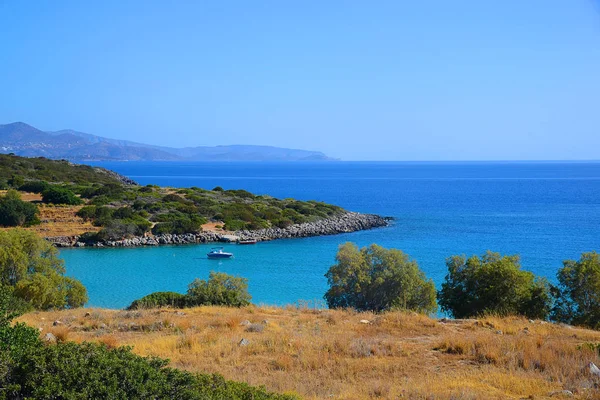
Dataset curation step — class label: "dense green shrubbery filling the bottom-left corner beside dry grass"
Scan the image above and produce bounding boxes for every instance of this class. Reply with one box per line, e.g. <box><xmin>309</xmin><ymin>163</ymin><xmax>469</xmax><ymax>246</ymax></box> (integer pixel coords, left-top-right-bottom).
<box><xmin>0</xmin><ymin>312</ymin><xmax>296</xmax><ymax>400</ymax></box>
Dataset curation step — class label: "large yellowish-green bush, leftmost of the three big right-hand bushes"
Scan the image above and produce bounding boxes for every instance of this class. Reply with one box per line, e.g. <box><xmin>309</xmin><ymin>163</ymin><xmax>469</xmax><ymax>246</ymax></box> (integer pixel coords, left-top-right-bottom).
<box><xmin>325</xmin><ymin>243</ymin><xmax>437</xmax><ymax>313</ymax></box>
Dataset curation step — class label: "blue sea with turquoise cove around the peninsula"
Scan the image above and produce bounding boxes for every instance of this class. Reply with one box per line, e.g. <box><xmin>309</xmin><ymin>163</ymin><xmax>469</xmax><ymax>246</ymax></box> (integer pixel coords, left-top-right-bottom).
<box><xmin>61</xmin><ymin>162</ymin><xmax>600</xmax><ymax>308</ymax></box>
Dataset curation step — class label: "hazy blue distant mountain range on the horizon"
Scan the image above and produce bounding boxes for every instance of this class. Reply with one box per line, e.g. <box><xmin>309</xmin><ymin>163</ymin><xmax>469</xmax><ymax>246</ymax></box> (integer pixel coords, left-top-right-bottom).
<box><xmin>0</xmin><ymin>122</ymin><xmax>332</xmax><ymax>161</ymax></box>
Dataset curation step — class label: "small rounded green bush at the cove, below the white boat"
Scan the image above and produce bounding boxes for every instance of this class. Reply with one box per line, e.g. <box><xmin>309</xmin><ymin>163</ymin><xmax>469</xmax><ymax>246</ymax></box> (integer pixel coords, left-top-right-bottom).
<box><xmin>187</xmin><ymin>271</ymin><xmax>252</xmax><ymax>307</ymax></box>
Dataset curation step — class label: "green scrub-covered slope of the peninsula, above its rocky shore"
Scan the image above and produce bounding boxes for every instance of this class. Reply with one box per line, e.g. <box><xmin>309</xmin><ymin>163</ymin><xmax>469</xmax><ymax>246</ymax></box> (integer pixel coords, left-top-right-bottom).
<box><xmin>0</xmin><ymin>155</ymin><xmax>344</xmax><ymax>240</ymax></box>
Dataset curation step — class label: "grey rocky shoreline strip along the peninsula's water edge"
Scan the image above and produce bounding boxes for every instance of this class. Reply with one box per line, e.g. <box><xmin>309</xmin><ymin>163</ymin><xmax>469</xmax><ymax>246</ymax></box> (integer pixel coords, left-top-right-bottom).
<box><xmin>45</xmin><ymin>212</ymin><xmax>389</xmax><ymax>247</ymax></box>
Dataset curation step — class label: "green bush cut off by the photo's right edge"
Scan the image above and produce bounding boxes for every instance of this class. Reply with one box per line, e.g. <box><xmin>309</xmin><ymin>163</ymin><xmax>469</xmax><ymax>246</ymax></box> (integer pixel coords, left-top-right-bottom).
<box><xmin>552</xmin><ymin>252</ymin><xmax>600</xmax><ymax>329</ymax></box>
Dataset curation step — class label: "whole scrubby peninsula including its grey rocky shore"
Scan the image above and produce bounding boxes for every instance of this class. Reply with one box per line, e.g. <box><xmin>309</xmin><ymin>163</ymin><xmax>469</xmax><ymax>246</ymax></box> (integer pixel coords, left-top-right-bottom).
<box><xmin>0</xmin><ymin>155</ymin><xmax>388</xmax><ymax>246</ymax></box>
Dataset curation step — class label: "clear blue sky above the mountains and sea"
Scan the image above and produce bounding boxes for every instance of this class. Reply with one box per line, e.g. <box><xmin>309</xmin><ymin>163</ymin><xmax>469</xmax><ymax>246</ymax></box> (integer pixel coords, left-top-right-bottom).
<box><xmin>0</xmin><ymin>0</ymin><xmax>600</xmax><ymax>160</ymax></box>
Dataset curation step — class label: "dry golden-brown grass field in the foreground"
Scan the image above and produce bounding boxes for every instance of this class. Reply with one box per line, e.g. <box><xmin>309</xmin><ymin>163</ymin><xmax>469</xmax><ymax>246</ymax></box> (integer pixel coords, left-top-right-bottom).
<box><xmin>20</xmin><ymin>307</ymin><xmax>600</xmax><ymax>399</ymax></box>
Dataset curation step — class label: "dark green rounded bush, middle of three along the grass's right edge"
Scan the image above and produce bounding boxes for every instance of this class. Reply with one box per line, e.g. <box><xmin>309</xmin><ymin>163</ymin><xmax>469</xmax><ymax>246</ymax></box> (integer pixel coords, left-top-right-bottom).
<box><xmin>438</xmin><ymin>251</ymin><xmax>552</xmax><ymax>319</ymax></box>
